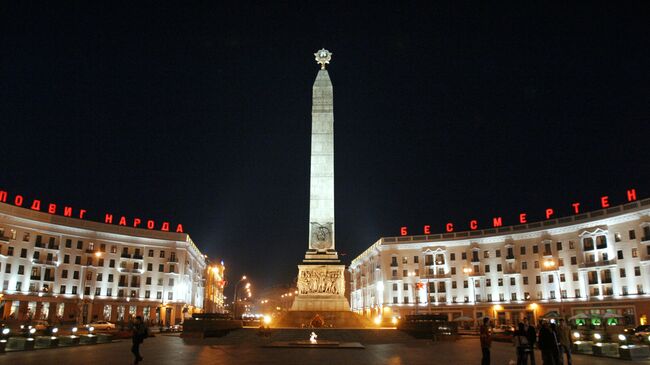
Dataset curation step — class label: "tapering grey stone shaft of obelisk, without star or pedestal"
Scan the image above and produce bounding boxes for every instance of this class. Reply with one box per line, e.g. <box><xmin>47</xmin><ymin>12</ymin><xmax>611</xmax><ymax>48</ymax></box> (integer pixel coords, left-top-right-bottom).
<box><xmin>309</xmin><ymin>69</ymin><xmax>334</xmax><ymax>252</ymax></box>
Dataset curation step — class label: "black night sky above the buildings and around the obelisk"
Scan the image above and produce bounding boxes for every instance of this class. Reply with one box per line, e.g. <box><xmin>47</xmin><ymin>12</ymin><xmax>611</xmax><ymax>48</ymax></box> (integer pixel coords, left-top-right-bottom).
<box><xmin>0</xmin><ymin>1</ymin><xmax>650</xmax><ymax>292</ymax></box>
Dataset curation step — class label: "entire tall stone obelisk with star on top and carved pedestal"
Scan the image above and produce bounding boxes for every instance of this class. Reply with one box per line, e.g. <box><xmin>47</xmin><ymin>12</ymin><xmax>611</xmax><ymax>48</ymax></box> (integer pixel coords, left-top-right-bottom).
<box><xmin>291</xmin><ymin>49</ymin><xmax>350</xmax><ymax>311</ymax></box>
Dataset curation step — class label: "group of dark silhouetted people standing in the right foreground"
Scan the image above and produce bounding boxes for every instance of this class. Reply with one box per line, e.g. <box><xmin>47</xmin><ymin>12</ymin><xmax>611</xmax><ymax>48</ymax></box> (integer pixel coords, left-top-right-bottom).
<box><xmin>479</xmin><ymin>318</ymin><xmax>571</xmax><ymax>365</ymax></box>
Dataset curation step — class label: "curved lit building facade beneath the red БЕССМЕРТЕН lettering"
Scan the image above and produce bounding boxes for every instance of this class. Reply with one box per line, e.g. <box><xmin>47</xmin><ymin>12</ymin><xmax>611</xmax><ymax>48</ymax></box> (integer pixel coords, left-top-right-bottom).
<box><xmin>349</xmin><ymin>199</ymin><xmax>650</xmax><ymax>324</ymax></box>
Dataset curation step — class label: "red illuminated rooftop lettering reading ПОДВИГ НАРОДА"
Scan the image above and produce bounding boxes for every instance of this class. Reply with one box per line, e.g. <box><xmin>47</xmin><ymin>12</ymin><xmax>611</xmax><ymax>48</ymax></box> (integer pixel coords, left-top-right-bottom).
<box><xmin>0</xmin><ymin>190</ymin><xmax>183</xmax><ymax>233</ymax></box>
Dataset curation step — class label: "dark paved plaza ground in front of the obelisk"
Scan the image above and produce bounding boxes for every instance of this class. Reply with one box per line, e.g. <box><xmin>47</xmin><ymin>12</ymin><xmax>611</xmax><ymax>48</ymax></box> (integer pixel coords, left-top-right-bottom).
<box><xmin>5</xmin><ymin>330</ymin><xmax>650</xmax><ymax>365</ymax></box>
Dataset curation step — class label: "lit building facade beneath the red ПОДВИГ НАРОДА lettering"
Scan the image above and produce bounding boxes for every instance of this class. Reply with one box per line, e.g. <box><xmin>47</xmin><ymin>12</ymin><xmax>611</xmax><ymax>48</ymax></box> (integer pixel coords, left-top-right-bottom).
<box><xmin>0</xmin><ymin>203</ymin><xmax>206</xmax><ymax>325</ymax></box>
